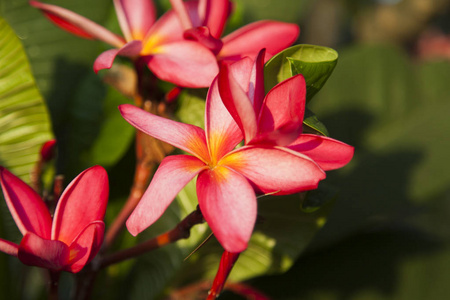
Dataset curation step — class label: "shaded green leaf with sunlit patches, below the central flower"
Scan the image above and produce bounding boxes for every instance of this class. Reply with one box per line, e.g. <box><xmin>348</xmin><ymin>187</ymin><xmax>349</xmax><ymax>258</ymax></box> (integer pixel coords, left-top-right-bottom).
<box><xmin>176</xmin><ymin>193</ymin><xmax>331</xmax><ymax>286</ymax></box>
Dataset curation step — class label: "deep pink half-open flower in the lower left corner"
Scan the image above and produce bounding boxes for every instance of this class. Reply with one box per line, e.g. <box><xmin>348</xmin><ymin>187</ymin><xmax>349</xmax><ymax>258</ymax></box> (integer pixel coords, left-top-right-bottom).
<box><xmin>0</xmin><ymin>166</ymin><xmax>109</xmax><ymax>273</ymax></box>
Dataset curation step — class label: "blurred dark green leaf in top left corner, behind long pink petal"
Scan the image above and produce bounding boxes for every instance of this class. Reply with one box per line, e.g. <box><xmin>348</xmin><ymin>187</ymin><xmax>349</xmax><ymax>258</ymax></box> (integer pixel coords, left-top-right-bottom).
<box><xmin>0</xmin><ymin>0</ymin><xmax>113</xmax><ymax>132</ymax></box>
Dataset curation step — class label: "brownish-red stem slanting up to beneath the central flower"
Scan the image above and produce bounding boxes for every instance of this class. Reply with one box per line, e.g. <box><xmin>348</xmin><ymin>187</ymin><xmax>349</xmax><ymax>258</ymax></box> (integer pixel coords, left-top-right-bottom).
<box><xmin>100</xmin><ymin>208</ymin><xmax>204</xmax><ymax>268</ymax></box>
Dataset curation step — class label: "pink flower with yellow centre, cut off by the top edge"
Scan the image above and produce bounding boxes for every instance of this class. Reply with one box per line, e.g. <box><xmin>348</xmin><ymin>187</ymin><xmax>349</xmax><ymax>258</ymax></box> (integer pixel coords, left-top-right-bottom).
<box><xmin>30</xmin><ymin>0</ymin><xmax>219</xmax><ymax>88</ymax></box>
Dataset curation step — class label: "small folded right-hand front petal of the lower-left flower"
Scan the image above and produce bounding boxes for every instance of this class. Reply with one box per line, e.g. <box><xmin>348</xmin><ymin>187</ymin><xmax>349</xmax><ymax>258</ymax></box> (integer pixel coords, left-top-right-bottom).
<box><xmin>64</xmin><ymin>221</ymin><xmax>105</xmax><ymax>273</ymax></box>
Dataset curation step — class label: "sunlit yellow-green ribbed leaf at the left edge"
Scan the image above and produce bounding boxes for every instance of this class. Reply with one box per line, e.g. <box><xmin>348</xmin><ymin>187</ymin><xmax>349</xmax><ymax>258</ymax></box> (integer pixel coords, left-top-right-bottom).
<box><xmin>0</xmin><ymin>18</ymin><xmax>53</xmax><ymax>181</ymax></box>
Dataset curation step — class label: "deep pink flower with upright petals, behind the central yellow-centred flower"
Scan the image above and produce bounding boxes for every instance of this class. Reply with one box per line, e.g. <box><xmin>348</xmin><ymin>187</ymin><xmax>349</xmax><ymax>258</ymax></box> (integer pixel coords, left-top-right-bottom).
<box><xmin>218</xmin><ymin>50</ymin><xmax>354</xmax><ymax>176</ymax></box>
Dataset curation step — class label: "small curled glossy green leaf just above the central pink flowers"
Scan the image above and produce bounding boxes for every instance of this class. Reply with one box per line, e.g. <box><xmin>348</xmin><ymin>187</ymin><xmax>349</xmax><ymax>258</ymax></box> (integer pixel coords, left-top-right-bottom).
<box><xmin>264</xmin><ymin>45</ymin><xmax>338</xmax><ymax>102</ymax></box>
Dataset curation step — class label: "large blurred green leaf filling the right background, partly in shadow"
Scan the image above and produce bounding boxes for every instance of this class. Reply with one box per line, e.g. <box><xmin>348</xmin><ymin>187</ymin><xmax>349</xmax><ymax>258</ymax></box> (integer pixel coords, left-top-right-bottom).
<box><xmin>252</xmin><ymin>46</ymin><xmax>450</xmax><ymax>300</ymax></box>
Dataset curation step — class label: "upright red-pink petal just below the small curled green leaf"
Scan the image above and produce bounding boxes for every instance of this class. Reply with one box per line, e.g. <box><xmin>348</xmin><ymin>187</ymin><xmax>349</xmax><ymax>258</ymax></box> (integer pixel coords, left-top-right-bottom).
<box><xmin>257</xmin><ymin>74</ymin><xmax>306</xmax><ymax>146</ymax></box>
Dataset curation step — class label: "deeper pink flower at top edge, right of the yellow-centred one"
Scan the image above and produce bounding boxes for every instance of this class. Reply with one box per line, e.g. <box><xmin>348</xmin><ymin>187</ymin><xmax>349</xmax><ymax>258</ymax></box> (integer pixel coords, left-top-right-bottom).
<box><xmin>171</xmin><ymin>0</ymin><xmax>300</xmax><ymax>62</ymax></box>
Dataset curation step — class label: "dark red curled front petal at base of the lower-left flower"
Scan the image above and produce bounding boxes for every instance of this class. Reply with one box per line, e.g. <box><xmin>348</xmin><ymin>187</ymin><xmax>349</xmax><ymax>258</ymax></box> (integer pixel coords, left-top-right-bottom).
<box><xmin>18</xmin><ymin>232</ymin><xmax>69</xmax><ymax>271</ymax></box>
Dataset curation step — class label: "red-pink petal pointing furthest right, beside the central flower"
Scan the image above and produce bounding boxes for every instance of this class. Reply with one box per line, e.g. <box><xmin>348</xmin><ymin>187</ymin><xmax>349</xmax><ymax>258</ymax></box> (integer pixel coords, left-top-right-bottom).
<box><xmin>288</xmin><ymin>134</ymin><xmax>354</xmax><ymax>171</ymax></box>
